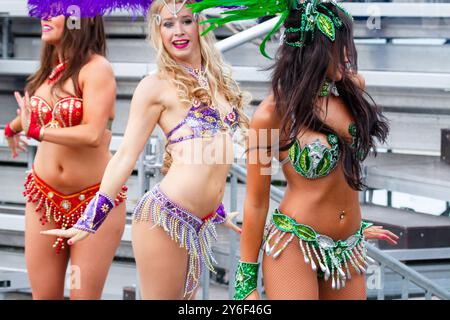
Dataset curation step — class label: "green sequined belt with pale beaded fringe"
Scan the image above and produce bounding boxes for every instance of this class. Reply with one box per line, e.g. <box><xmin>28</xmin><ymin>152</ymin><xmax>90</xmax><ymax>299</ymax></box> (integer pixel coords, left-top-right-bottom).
<box><xmin>263</xmin><ymin>210</ymin><xmax>374</xmax><ymax>290</ymax></box>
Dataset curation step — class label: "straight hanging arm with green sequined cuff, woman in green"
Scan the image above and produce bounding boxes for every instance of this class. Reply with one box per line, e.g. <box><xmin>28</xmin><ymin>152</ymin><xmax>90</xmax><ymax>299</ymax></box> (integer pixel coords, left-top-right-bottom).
<box><xmin>235</xmin><ymin>97</ymin><xmax>276</xmax><ymax>300</ymax></box>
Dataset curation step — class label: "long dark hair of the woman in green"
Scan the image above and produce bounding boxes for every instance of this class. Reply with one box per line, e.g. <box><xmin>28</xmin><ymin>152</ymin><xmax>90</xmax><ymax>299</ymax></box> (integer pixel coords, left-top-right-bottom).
<box><xmin>272</xmin><ymin>3</ymin><xmax>389</xmax><ymax>190</ymax></box>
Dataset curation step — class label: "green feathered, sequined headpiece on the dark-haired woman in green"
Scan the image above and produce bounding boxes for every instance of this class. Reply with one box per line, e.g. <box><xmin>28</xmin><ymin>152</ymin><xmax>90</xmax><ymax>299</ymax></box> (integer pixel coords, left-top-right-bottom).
<box><xmin>187</xmin><ymin>0</ymin><xmax>351</xmax><ymax>59</ymax></box>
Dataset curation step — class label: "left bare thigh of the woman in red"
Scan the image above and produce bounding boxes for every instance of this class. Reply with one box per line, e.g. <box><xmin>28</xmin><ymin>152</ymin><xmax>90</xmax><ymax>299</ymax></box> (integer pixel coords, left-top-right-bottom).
<box><xmin>25</xmin><ymin>203</ymin><xmax>69</xmax><ymax>300</ymax></box>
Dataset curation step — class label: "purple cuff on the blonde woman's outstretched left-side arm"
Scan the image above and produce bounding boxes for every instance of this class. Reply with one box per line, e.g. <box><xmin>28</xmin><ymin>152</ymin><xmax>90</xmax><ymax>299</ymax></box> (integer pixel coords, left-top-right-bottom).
<box><xmin>73</xmin><ymin>192</ymin><xmax>114</xmax><ymax>233</ymax></box>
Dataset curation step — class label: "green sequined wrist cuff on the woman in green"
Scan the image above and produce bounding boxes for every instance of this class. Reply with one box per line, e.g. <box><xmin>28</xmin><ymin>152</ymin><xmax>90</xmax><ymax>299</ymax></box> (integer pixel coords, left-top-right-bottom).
<box><xmin>233</xmin><ymin>261</ymin><xmax>259</xmax><ymax>300</ymax></box>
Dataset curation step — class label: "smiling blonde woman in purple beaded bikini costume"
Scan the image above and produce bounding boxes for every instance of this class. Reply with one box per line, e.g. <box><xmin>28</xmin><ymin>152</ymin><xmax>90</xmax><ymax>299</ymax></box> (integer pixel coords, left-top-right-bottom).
<box><xmin>47</xmin><ymin>0</ymin><xmax>247</xmax><ymax>299</ymax></box>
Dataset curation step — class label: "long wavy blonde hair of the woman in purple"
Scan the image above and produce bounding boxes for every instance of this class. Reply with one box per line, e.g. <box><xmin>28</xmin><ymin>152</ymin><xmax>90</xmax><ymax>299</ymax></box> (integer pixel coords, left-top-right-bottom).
<box><xmin>147</xmin><ymin>0</ymin><xmax>251</xmax><ymax>174</ymax></box>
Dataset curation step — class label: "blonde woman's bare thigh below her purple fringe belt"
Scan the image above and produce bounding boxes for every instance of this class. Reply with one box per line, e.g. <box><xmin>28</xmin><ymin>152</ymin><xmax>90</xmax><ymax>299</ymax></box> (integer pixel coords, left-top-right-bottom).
<box><xmin>132</xmin><ymin>221</ymin><xmax>188</xmax><ymax>300</ymax></box>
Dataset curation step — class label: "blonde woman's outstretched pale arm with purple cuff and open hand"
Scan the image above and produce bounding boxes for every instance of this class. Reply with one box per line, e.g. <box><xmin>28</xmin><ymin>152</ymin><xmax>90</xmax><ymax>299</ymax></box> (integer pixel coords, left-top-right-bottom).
<box><xmin>41</xmin><ymin>76</ymin><xmax>164</xmax><ymax>240</ymax></box>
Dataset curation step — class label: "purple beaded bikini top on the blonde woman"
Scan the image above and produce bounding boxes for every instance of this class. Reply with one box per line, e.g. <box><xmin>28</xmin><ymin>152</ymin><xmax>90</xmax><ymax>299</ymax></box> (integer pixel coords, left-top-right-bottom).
<box><xmin>167</xmin><ymin>100</ymin><xmax>238</xmax><ymax>145</ymax></box>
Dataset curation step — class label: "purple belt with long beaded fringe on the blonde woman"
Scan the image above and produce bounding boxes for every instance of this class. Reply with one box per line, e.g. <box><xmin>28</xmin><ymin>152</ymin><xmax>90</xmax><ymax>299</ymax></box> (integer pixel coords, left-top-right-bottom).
<box><xmin>133</xmin><ymin>185</ymin><xmax>217</xmax><ymax>296</ymax></box>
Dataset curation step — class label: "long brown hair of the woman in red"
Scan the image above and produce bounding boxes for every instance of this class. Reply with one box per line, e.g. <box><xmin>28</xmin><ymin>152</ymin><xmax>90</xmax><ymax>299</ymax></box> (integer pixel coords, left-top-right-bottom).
<box><xmin>26</xmin><ymin>16</ymin><xmax>106</xmax><ymax>98</ymax></box>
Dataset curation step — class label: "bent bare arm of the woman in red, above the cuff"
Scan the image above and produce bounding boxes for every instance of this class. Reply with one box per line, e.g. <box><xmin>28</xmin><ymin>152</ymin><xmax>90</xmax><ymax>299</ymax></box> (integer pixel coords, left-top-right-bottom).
<box><xmin>42</xmin><ymin>57</ymin><xmax>116</xmax><ymax>147</ymax></box>
